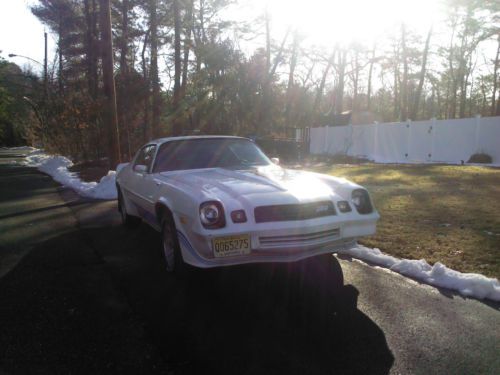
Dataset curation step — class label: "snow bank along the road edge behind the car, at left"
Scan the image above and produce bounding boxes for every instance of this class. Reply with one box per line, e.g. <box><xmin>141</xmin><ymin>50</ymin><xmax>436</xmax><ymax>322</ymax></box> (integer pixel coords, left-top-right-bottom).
<box><xmin>22</xmin><ymin>149</ymin><xmax>125</xmax><ymax>203</ymax></box>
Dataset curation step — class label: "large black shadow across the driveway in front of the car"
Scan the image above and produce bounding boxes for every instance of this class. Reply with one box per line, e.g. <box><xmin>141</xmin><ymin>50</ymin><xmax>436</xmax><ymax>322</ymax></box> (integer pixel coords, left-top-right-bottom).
<box><xmin>0</xmin><ymin>225</ymin><xmax>394</xmax><ymax>374</ymax></box>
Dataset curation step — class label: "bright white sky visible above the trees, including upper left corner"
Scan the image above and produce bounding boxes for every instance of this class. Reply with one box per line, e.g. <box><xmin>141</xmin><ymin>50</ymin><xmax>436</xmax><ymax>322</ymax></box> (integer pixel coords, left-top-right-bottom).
<box><xmin>0</xmin><ymin>0</ymin><xmax>496</xmax><ymax>83</ymax></box>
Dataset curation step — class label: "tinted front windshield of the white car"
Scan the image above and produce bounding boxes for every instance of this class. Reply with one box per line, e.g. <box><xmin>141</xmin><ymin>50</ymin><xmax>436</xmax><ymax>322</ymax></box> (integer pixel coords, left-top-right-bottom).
<box><xmin>153</xmin><ymin>138</ymin><xmax>271</xmax><ymax>173</ymax></box>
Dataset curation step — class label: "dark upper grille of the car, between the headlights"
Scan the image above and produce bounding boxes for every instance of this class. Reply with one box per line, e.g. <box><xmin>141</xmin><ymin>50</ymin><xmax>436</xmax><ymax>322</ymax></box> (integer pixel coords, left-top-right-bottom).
<box><xmin>254</xmin><ymin>201</ymin><xmax>335</xmax><ymax>223</ymax></box>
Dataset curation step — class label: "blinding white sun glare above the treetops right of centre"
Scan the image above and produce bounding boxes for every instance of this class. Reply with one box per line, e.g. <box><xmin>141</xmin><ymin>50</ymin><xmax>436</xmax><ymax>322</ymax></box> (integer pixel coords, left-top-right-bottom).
<box><xmin>242</xmin><ymin>0</ymin><xmax>439</xmax><ymax>45</ymax></box>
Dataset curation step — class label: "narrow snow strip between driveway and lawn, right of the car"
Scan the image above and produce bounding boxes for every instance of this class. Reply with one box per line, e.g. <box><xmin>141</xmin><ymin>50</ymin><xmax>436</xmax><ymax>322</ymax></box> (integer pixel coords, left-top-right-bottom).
<box><xmin>339</xmin><ymin>245</ymin><xmax>500</xmax><ymax>301</ymax></box>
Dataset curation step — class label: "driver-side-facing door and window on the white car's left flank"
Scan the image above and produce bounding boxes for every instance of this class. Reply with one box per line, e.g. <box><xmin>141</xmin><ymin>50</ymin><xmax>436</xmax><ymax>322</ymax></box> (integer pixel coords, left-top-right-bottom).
<box><xmin>128</xmin><ymin>145</ymin><xmax>157</xmax><ymax>221</ymax></box>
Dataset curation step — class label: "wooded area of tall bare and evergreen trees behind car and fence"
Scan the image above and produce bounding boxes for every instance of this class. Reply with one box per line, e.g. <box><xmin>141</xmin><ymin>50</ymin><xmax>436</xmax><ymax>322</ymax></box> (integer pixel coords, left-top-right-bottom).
<box><xmin>0</xmin><ymin>0</ymin><xmax>500</xmax><ymax>164</ymax></box>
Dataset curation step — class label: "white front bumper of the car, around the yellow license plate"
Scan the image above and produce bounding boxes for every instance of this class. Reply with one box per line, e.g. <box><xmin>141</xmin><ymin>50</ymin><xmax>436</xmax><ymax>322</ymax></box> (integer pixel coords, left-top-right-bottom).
<box><xmin>178</xmin><ymin>212</ymin><xmax>379</xmax><ymax>268</ymax></box>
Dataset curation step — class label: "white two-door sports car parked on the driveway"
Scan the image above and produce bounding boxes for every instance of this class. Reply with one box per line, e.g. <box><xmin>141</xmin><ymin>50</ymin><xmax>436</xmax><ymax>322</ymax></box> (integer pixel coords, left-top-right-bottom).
<box><xmin>116</xmin><ymin>136</ymin><xmax>379</xmax><ymax>271</ymax></box>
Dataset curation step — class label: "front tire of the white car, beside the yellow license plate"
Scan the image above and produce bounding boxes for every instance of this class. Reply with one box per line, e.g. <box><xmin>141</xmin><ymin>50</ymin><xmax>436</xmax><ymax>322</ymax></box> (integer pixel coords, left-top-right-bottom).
<box><xmin>161</xmin><ymin>213</ymin><xmax>186</xmax><ymax>276</ymax></box>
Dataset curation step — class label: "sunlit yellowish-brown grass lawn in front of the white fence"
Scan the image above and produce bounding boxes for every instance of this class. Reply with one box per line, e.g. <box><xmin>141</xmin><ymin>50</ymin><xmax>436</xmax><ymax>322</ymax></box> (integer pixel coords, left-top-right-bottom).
<box><xmin>316</xmin><ymin>164</ymin><xmax>500</xmax><ymax>279</ymax></box>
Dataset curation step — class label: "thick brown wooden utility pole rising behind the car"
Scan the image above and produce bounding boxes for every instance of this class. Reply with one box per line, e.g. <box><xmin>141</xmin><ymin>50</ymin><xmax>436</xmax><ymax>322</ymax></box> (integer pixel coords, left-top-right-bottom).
<box><xmin>100</xmin><ymin>0</ymin><xmax>121</xmax><ymax>169</ymax></box>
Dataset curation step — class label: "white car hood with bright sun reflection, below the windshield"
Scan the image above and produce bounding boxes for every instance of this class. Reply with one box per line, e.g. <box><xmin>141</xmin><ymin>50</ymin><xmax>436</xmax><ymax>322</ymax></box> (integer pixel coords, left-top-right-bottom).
<box><xmin>160</xmin><ymin>166</ymin><xmax>352</xmax><ymax>206</ymax></box>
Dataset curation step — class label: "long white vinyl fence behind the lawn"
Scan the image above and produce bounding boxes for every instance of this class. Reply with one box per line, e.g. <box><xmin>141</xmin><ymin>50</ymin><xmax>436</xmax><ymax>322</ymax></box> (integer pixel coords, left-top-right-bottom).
<box><xmin>310</xmin><ymin>116</ymin><xmax>500</xmax><ymax>164</ymax></box>
